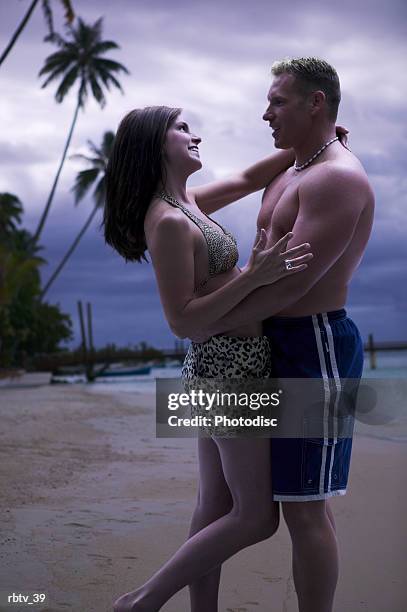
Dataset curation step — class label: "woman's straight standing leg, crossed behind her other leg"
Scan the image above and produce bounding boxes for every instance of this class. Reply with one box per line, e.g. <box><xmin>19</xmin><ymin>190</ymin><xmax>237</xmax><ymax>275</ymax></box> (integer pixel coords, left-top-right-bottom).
<box><xmin>189</xmin><ymin>438</ymin><xmax>233</xmax><ymax>612</ymax></box>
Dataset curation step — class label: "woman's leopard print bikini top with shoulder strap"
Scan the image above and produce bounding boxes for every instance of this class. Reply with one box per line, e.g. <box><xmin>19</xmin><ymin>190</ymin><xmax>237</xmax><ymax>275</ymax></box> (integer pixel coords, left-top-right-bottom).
<box><xmin>157</xmin><ymin>192</ymin><xmax>239</xmax><ymax>291</ymax></box>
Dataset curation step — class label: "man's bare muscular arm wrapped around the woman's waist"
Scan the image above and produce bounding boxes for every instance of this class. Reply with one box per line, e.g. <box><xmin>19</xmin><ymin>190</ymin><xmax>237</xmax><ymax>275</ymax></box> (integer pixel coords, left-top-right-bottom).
<box><xmin>196</xmin><ymin>168</ymin><xmax>366</xmax><ymax>336</ymax></box>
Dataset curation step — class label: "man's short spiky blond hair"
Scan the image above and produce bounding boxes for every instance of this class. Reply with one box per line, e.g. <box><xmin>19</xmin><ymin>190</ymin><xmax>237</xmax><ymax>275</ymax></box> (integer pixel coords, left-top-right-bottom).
<box><xmin>271</xmin><ymin>57</ymin><xmax>341</xmax><ymax>121</ymax></box>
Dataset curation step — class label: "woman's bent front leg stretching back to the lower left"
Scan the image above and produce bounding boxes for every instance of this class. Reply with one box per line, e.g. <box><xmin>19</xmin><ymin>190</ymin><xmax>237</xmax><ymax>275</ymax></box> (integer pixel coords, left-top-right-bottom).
<box><xmin>114</xmin><ymin>438</ymin><xmax>278</xmax><ymax>612</ymax></box>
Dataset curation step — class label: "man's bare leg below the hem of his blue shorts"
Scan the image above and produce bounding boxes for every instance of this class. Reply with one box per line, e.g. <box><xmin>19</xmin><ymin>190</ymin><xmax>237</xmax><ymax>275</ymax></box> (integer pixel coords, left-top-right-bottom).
<box><xmin>282</xmin><ymin>500</ymin><xmax>338</xmax><ymax>612</ymax></box>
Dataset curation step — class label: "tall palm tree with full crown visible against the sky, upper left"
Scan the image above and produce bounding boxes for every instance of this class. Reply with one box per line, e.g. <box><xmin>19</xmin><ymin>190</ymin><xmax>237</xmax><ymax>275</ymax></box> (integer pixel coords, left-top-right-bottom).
<box><xmin>34</xmin><ymin>18</ymin><xmax>129</xmax><ymax>242</ymax></box>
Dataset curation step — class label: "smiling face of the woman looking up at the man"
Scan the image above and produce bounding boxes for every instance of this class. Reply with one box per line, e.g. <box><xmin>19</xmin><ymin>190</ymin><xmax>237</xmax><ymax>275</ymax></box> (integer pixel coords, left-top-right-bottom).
<box><xmin>164</xmin><ymin>113</ymin><xmax>202</xmax><ymax>175</ymax></box>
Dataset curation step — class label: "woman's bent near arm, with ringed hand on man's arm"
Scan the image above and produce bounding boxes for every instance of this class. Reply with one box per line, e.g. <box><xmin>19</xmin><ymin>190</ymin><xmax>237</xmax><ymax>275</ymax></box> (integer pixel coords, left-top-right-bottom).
<box><xmin>148</xmin><ymin>211</ymin><xmax>312</xmax><ymax>338</ymax></box>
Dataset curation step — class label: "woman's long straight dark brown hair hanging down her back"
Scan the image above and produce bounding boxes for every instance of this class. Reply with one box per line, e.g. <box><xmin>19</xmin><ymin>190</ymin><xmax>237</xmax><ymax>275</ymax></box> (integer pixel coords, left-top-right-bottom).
<box><xmin>102</xmin><ymin>106</ymin><xmax>181</xmax><ymax>262</ymax></box>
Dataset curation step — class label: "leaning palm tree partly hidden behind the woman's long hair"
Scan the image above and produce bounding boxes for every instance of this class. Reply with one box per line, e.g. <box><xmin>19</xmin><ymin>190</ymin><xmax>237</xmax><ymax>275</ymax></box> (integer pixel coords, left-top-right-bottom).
<box><xmin>41</xmin><ymin>132</ymin><xmax>114</xmax><ymax>298</ymax></box>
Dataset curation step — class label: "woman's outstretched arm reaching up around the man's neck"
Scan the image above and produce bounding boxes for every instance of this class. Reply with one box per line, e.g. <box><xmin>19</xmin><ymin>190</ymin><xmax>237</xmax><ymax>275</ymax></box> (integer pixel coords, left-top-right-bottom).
<box><xmin>188</xmin><ymin>149</ymin><xmax>294</xmax><ymax>214</ymax></box>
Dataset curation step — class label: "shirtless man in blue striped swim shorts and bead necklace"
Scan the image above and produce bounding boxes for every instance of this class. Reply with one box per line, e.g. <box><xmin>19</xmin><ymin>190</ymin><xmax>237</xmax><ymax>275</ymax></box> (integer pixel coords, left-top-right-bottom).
<box><xmin>196</xmin><ymin>58</ymin><xmax>374</xmax><ymax>612</ymax></box>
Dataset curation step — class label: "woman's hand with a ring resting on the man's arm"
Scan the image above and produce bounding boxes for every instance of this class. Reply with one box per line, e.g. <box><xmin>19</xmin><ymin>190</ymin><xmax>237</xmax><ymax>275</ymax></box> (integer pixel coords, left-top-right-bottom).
<box><xmin>242</xmin><ymin>229</ymin><xmax>313</xmax><ymax>287</ymax></box>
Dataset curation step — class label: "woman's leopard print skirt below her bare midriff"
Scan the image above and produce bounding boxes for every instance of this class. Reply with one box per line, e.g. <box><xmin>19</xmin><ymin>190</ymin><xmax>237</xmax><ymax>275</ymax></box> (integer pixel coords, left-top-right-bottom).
<box><xmin>181</xmin><ymin>336</ymin><xmax>271</xmax><ymax>437</ymax></box>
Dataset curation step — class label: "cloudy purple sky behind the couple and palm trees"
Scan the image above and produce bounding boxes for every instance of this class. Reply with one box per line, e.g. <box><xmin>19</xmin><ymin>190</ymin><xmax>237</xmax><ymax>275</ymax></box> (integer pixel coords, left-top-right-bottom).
<box><xmin>0</xmin><ymin>0</ymin><xmax>407</xmax><ymax>346</ymax></box>
